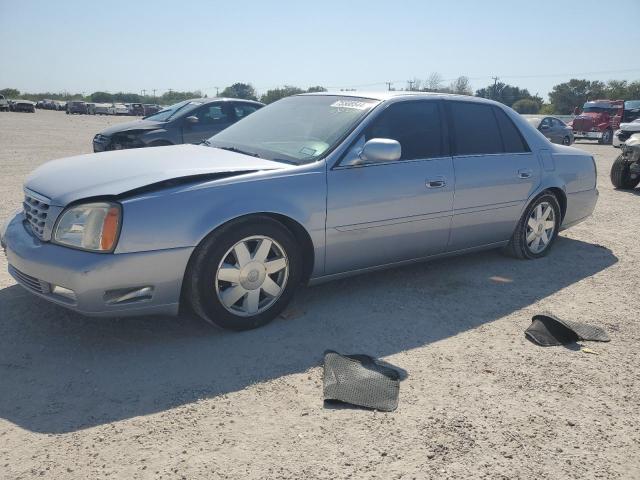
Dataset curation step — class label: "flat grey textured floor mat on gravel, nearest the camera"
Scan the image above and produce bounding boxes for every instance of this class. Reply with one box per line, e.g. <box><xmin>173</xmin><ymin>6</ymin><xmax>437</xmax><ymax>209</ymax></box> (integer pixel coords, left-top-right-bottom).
<box><xmin>324</xmin><ymin>350</ymin><xmax>400</xmax><ymax>412</ymax></box>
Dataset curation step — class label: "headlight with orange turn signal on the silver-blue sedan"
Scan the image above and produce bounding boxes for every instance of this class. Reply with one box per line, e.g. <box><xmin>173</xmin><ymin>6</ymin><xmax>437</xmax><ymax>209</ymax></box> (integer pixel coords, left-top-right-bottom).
<box><xmin>53</xmin><ymin>202</ymin><xmax>122</xmax><ymax>252</ymax></box>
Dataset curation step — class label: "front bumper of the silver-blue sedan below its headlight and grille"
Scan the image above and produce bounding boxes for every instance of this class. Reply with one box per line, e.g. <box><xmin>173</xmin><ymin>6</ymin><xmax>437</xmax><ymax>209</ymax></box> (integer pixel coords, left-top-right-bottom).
<box><xmin>1</xmin><ymin>213</ymin><xmax>193</xmax><ymax>317</ymax></box>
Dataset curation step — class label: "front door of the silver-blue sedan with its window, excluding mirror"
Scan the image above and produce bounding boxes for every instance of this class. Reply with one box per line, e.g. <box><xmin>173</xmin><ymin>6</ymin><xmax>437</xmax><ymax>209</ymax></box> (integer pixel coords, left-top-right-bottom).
<box><xmin>325</xmin><ymin>100</ymin><xmax>454</xmax><ymax>274</ymax></box>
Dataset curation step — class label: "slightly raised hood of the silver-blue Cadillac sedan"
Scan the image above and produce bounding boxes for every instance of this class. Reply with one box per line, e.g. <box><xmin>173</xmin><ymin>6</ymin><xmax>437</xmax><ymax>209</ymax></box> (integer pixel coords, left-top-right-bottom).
<box><xmin>25</xmin><ymin>141</ymin><xmax>291</xmax><ymax>207</ymax></box>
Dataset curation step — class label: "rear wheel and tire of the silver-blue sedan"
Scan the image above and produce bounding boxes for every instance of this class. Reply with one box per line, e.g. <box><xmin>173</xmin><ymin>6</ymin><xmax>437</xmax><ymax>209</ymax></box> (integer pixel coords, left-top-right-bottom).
<box><xmin>505</xmin><ymin>192</ymin><xmax>562</xmax><ymax>260</ymax></box>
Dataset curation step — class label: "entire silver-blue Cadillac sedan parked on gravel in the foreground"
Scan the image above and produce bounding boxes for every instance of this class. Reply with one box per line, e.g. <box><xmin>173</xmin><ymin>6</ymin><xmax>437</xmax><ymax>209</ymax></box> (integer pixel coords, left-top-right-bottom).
<box><xmin>1</xmin><ymin>92</ymin><xmax>598</xmax><ymax>330</ymax></box>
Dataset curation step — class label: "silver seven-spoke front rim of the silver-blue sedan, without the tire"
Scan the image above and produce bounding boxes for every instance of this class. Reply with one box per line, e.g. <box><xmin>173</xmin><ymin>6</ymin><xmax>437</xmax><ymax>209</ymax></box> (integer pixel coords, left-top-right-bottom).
<box><xmin>215</xmin><ymin>235</ymin><xmax>289</xmax><ymax>317</ymax></box>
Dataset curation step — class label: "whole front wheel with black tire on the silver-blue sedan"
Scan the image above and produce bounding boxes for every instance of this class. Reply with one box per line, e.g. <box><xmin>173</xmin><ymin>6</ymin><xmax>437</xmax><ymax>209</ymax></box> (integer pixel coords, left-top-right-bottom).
<box><xmin>183</xmin><ymin>217</ymin><xmax>302</xmax><ymax>331</ymax></box>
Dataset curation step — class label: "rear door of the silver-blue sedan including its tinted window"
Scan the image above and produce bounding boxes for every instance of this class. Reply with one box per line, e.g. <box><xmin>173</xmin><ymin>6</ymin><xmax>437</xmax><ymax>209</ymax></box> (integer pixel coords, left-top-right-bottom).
<box><xmin>447</xmin><ymin>101</ymin><xmax>541</xmax><ymax>251</ymax></box>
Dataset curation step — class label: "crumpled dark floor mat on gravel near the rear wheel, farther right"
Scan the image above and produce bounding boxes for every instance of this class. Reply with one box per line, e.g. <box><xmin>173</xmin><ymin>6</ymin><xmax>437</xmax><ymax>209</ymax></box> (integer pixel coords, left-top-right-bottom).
<box><xmin>524</xmin><ymin>313</ymin><xmax>609</xmax><ymax>347</ymax></box>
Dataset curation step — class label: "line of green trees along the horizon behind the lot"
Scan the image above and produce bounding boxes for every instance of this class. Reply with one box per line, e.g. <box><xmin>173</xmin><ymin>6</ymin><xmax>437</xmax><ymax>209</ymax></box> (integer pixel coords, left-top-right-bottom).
<box><xmin>0</xmin><ymin>73</ymin><xmax>640</xmax><ymax>115</ymax></box>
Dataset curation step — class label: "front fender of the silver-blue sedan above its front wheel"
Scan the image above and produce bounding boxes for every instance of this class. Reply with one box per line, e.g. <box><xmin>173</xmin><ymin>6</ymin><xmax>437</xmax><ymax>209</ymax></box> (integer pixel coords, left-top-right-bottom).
<box><xmin>115</xmin><ymin>167</ymin><xmax>326</xmax><ymax>274</ymax></box>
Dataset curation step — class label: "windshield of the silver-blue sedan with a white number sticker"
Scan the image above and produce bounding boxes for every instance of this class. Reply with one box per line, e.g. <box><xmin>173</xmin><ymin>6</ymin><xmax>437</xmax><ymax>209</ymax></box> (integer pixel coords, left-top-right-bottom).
<box><xmin>207</xmin><ymin>95</ymin><xmax>379</xmax><ymax>165</ymax></box>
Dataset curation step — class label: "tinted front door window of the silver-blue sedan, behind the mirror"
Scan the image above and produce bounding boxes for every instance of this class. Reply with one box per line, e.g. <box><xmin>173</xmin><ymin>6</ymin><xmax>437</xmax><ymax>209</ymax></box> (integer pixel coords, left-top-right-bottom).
<box><xmin>365</xmin><ymin>101</ymin><xmax>444</xmax><ymax>160</ymax></box>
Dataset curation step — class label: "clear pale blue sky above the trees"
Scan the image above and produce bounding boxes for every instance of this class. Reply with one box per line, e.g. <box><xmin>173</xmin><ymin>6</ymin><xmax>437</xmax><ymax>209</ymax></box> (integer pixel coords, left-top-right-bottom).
<box><xmin>0</xmin><ymin>0</ymin><xmax>640</xmax><ymax>99</ymax></box>
